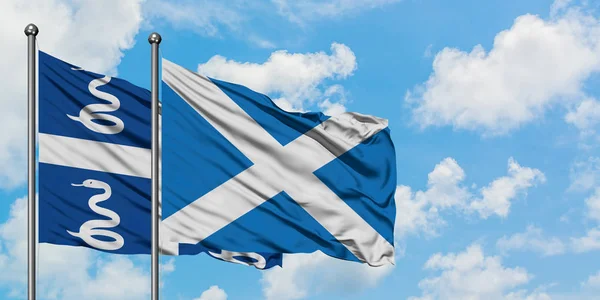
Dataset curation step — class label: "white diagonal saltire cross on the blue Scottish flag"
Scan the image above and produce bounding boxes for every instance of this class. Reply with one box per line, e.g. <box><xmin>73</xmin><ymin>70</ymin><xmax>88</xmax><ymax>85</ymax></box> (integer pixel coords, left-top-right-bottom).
<box><xmin>161</xmin><ymin>59</ymin><xmax>394</xmax><ymax>266</ymax></box>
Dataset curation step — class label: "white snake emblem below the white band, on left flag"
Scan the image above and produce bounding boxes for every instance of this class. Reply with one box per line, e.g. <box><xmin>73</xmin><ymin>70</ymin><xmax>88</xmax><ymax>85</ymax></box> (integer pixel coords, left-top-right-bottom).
<box><xmin>67</xmin><ymin>179</ymin><xmax>125</xmax><ymax>251</ymax></box>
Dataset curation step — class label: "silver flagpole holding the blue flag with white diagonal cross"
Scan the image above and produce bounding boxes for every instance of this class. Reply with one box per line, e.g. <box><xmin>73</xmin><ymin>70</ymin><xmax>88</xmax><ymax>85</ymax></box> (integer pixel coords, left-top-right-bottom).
<box><xmin>148</xmin><ymin>32</ymin><xmax>162</xmax><ymax>300</ymax></box>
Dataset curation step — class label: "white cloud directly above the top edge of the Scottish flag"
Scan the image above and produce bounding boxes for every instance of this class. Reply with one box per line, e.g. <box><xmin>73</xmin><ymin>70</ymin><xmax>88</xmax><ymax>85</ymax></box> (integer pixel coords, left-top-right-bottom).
<box><xmin>198</xmin><ymin>43</ymin><xmax>356</xmax><ymax>111</ymax></box>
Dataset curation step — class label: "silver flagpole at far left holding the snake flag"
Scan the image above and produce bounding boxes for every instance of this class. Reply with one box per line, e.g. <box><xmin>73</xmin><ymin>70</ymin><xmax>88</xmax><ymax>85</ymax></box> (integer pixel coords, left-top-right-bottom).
<box><xmin>25</xmin><ymin>24</ymin><xmax>39</xmax><ymax>300</ymax></box>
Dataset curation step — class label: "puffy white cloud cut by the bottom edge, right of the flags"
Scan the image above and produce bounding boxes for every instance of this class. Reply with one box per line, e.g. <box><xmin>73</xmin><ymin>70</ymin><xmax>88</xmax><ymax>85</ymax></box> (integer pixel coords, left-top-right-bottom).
<box><xmin>410</xmin><ymin>244</ymin><xmax>539</xmax><ymax>300</ymax></box>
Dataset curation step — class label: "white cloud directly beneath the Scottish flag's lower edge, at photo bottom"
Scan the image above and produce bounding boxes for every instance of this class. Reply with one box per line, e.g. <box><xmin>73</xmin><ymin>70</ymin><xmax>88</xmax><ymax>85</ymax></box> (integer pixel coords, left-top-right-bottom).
<box><xmin>261</xmin><ymin>252</ymin><xmax>394</xmax><ymax>300</ymax></box>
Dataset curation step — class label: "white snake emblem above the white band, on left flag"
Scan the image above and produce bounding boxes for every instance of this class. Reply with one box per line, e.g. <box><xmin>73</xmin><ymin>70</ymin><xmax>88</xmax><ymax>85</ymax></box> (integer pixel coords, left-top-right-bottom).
<box><xmin>67</xmin><ymin>68</ymin><xmax>125</xmax><ymax>134</ymax></box>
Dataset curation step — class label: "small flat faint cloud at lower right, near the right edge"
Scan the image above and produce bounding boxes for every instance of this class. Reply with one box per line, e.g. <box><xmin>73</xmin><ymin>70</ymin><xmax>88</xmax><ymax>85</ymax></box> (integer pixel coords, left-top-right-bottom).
<box><xmin>496</xmin><ymin>226</ymin><xmax>566</xmax><ymax>256</ymax></box>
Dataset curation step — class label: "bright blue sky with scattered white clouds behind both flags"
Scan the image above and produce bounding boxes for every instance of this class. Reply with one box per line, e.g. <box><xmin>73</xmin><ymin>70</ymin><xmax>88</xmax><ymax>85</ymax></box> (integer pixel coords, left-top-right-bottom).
<box><xmin>0</xmin><ymin>0</ymin><xmax>600</xmax><ymax>300</ymax></box>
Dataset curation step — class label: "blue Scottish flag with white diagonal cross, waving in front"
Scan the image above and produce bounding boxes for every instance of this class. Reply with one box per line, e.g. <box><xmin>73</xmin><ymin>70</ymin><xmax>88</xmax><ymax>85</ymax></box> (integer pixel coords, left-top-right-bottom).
<box><xmin>161</xmin><ymin>59</ymin><xmax>396</xmax><ymax>266</ymax></box>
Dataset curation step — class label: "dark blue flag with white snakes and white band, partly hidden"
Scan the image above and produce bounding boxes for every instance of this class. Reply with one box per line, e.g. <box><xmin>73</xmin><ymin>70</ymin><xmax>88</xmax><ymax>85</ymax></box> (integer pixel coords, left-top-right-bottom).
<box><xmin>39</xmin><ymin>51</ymin><xmax>282</xmax><ymax>268</ymax></box>
